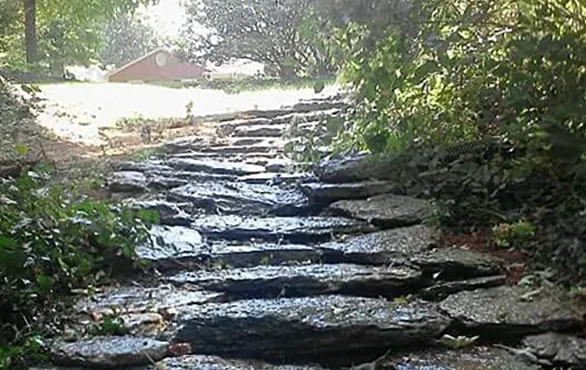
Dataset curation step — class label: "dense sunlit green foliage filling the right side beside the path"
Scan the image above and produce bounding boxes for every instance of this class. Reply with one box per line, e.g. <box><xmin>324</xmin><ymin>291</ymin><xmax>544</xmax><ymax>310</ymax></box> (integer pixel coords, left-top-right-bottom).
<box><xmin>333</xmin><ymin>0</ymin><xmax>586</xmax><ymax>279</ymax></box>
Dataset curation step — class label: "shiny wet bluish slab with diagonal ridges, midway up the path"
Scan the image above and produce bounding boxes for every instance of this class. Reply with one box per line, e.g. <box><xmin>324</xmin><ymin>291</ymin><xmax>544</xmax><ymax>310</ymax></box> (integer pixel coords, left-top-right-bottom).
<box><xmin>169</xmin><ymin>182</ymin><xmax>309</xmax><ymax>216</ymax></box>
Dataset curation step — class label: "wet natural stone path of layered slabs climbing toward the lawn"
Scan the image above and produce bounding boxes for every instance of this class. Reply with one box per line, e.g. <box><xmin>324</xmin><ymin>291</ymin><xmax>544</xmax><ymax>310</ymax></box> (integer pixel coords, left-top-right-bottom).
<box><xmin>38</xmin><ymin>96</ymin><xmax>586</xmax><ymax>370</ymax></box>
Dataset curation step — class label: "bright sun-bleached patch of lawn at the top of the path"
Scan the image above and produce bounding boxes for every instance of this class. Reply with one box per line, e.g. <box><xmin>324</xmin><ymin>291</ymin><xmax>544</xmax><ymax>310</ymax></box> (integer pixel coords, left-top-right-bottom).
<box><xmin>39</xmin><ymin>83</ymin><xmax>338</xmax><ymax>145</ymax></box>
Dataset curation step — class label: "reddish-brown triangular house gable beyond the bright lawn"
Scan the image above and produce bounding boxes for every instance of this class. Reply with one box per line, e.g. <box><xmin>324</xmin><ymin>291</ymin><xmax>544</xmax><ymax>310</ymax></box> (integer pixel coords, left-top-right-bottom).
<box><xmin>108</xmin><ymin>53</ymin><xmax>205</xmax><ymax>82</ymax></box>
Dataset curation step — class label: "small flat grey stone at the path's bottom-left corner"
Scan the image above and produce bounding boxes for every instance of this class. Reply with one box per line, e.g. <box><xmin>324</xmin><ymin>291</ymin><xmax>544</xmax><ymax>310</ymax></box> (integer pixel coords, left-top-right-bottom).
<box><xmin>51</xmin><ymin>337</ymin><xmax>169</xmax><ymax>369</ymax></box>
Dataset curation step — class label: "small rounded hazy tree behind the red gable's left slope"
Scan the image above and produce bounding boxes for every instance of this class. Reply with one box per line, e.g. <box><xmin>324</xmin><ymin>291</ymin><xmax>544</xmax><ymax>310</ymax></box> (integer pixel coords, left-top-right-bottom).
<box><xmin>100</xmin><ymin>13</ymin><xmax>163</xmax><ymax>67</ymax></box>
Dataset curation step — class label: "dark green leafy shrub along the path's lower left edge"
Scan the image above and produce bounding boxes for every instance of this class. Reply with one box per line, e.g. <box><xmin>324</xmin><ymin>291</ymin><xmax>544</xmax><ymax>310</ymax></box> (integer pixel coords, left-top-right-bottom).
<box><xmin>0</xmin><ymin>172</ymin><xmax>157</xmax><ymax>368</ymax></box>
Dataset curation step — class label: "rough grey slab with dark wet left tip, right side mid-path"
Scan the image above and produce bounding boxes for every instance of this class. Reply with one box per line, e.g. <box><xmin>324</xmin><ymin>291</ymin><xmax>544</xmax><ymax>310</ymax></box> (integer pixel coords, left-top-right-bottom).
<box><xmin>318</xmin><ymin>225</ymin><xmax>433</xmax><ymax>265</ymax></box>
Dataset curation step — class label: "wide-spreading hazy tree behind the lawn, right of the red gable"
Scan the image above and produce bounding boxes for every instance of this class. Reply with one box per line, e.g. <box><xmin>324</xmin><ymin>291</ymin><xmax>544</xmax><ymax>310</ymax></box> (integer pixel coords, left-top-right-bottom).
<box><xmin>183</xmin><ymin>0</ymin><xmax>336</xmax><ymax>79</ymax></box>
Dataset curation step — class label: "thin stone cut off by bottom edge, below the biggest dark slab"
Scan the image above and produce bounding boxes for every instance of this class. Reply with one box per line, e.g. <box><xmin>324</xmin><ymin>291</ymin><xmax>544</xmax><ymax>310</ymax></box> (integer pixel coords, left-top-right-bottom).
<box><xmin>152</xmin><ymin>355</ymin><xmax>322</xmax><ymax>370</ymax></box>
